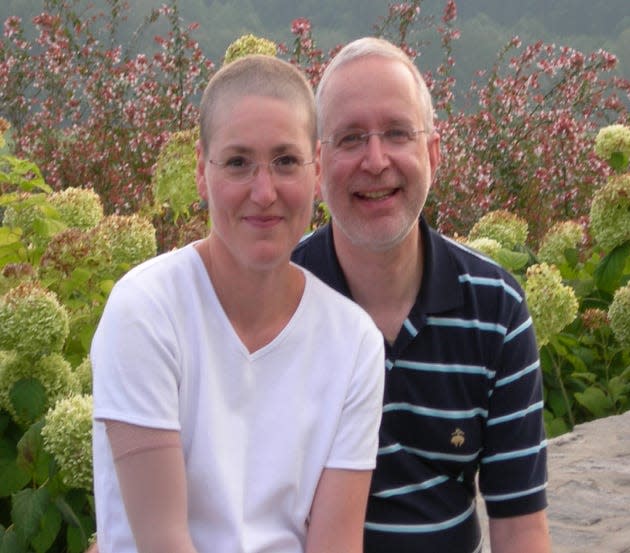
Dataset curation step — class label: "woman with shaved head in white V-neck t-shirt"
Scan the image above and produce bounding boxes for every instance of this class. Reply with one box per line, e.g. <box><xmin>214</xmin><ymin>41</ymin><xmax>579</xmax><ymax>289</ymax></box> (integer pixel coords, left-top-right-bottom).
<box><xmin>91</xmin><ymin>56</ymin><xmax>384</xmax><ymax>553</ymax></box>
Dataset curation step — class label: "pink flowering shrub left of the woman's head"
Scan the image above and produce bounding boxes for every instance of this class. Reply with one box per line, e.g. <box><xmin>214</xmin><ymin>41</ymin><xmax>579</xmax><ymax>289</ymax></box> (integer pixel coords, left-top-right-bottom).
<box><xmin>0</xmin><ymin>0</ymin><xmax>212</xmax><ymax>213</ymax></box>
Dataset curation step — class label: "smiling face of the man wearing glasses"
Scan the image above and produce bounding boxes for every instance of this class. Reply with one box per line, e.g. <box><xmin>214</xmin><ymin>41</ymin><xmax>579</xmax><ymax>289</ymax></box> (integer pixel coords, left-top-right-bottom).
<box><xmin>320</xmin><ymin>56</ymin><xmax>439</xmax><ymax>251</ymax></box>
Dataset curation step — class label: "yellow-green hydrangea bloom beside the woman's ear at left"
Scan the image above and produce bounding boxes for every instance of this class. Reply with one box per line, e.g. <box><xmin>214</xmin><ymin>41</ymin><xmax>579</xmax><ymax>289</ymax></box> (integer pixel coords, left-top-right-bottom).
<box><xmin>152</xmin><ymin>129</ymin><xmax>199</xmax><ymax>221</ymax></box>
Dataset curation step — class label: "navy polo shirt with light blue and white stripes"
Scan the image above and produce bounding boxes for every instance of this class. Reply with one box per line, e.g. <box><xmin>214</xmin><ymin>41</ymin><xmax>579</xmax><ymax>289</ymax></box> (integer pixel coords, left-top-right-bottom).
<box><xmin>293</xmin><ymin>218</ymin><xmax>547</xmax><ymax>553</ymax></box>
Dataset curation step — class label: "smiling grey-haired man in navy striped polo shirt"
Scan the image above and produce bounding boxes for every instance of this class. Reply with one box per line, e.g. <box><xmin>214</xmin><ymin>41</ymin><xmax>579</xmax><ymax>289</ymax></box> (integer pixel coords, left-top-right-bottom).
<box><xmin>293</xmin><ymin>38</ymin><xmax>550</xmax><ymax>553</ymax></box>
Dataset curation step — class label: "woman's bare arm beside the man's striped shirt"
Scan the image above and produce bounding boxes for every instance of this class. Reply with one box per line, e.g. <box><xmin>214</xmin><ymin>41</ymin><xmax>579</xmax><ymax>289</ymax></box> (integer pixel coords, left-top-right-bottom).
<box><xmin>306</xmin><ymin>469</ymin><xmax>372</xmax><ymax>553</ymax></box>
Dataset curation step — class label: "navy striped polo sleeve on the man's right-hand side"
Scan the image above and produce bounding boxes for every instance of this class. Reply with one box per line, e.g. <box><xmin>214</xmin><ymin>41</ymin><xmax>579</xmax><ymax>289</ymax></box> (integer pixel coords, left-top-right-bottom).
<box><xmin>479</xmin><ymin>291</ymin><xmax>547</xmax><ymax>517</ymax></box>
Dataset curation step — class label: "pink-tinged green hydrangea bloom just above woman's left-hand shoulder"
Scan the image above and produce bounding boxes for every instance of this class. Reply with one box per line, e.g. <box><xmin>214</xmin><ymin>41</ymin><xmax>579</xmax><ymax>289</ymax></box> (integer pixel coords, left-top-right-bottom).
<box><xmin>95</xmin><ymin>214</ymin><xmax>157</xmax><ymax>270</ymax></box>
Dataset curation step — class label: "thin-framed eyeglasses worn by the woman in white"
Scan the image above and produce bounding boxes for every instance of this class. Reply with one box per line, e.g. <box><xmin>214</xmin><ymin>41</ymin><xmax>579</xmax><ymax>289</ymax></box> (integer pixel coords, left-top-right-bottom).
<box><xmin>208</xmin><ymin>154</ymin><xmax>315</xmax><ymax>184</ymax></box>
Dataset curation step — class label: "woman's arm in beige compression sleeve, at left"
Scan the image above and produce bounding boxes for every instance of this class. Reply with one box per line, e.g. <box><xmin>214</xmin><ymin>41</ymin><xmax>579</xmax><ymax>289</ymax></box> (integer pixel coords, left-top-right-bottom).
<box><xmin>105</xmin><ymin>421</ymin><xmax>196</xmax><ymax>553</ymax></box>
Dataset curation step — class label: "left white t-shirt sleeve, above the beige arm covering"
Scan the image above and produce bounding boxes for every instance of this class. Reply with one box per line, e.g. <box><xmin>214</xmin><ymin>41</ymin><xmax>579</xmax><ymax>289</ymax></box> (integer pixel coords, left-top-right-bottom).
<box><xmin>90</xmin><ymin>279</ymin><xmax>180</xmax><ymax>430</ymax></box>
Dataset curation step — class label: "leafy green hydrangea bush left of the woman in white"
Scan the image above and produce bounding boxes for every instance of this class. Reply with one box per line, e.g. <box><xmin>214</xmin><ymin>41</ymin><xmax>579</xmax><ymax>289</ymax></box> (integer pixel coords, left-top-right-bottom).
<box><xmin>0</xmin><ymin>120</ymin><xmax>156</xmax><ymax>553</ymax></box>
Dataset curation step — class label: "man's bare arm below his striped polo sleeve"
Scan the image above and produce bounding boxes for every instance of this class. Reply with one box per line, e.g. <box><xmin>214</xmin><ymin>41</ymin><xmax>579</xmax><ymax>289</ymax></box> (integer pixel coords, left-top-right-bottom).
<box><xmin>489</xmin><ymin>511</ymin><xmax>551</xmax><ymax>553</ymax></box>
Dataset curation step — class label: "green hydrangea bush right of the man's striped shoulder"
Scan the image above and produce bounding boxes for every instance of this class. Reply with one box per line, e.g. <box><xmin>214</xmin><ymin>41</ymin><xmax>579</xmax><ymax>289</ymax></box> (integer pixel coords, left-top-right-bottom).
<box><xmin>461</xmin><ymin>125</ymin><xmax>630</xmax><ymax>436</ymax></box>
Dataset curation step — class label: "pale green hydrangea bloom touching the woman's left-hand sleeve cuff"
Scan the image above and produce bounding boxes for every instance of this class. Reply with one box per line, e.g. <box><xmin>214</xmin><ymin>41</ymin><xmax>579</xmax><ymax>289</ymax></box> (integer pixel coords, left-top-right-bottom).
<box><xmin>42</xmin><ymin>395</ymin><xmax>93</xmax><ymax>491</ymax></box>
